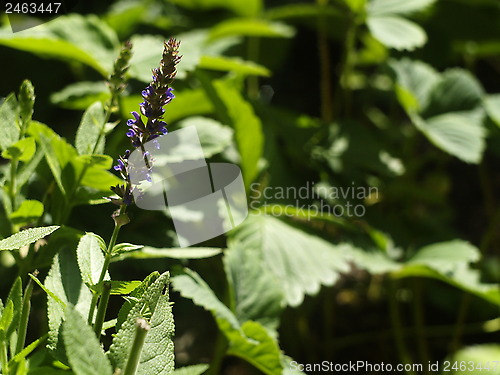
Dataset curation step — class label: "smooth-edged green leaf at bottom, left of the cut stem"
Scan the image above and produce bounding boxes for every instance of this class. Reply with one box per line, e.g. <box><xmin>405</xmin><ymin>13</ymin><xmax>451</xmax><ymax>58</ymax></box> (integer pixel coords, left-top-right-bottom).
<box><xmin>62</xmin><ymin>306</ymin><xmax>113</xmax><ymax>375</ymax></box>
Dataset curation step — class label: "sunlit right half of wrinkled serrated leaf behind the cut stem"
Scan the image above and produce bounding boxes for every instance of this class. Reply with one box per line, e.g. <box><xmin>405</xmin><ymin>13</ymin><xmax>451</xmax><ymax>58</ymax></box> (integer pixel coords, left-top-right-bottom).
<box><xmin>137</xmin><ymin>287</ymin><xmax>175</xmax><ymax>375</ymax></box>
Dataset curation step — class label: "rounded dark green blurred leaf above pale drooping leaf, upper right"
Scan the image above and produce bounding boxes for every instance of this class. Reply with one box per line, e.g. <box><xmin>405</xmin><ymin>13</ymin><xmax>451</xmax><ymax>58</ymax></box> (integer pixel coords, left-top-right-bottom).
<box><xmin>422</xmin><ymin>69</ymin><xmax>484</xmax><ymax>118</ymax></box>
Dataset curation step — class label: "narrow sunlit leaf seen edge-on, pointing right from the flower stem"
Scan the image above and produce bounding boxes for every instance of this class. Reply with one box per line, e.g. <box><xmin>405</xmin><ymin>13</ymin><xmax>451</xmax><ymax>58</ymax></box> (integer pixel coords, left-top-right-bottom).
<box><xmin>117</xmin><ymin>246</ymin><xmax>222</xmax><ymax>260</ymax></box>
